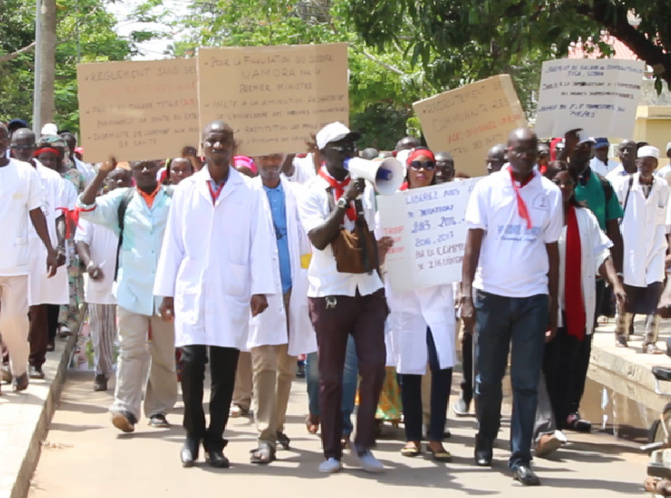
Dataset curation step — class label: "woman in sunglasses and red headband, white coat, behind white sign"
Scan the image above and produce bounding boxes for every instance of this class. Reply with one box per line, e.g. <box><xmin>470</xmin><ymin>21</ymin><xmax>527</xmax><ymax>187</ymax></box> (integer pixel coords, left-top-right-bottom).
<box><xmin>386</xmin><ymin>149</ymin><xmax>456</xmax><ymax>462</ymax></box>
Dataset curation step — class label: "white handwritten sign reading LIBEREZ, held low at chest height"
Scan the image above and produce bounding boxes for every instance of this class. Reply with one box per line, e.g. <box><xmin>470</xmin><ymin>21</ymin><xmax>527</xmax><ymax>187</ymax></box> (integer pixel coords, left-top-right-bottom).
<box><xmin>377</xmin><ymin>178</ymin><xmax>479</xmax><ymax>292</ymax></box>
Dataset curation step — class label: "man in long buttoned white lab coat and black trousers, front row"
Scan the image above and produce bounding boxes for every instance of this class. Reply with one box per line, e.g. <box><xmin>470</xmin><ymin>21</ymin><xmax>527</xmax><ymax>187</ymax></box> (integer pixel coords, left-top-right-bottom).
<box><xmin>154</xmin><ymin>121</ymin><xmax>276</xmax><ymax>468</ymax></box>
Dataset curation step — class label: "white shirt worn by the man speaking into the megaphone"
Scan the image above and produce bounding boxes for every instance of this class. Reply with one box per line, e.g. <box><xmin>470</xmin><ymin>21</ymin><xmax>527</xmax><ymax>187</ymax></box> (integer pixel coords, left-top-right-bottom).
<box><xmin>298</xmin><ymin>176</ymin><xmax>382</xmax><ymax>297</ymax></box>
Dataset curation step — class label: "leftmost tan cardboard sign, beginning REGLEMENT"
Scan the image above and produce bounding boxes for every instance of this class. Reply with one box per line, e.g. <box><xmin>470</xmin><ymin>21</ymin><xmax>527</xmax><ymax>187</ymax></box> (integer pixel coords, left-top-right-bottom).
<box><xmin>77</xmin><ymin>59</ymin><xmax>200</xmax><ymax>162</ymax></box>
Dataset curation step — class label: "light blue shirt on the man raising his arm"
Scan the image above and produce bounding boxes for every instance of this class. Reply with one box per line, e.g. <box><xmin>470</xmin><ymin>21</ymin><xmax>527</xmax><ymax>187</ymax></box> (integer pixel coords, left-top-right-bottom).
<box><xmin>77</xmin><ymin>187</ymin><xmax>172</xmax><ymax>316</ymax></box>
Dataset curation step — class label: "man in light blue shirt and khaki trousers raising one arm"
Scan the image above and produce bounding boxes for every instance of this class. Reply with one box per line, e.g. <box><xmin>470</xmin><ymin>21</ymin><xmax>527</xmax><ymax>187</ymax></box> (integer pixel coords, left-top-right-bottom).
<box><xmin>77</xmin><ymin>159</ymin><xmax>177</xmax><ymax>432</ymax></box>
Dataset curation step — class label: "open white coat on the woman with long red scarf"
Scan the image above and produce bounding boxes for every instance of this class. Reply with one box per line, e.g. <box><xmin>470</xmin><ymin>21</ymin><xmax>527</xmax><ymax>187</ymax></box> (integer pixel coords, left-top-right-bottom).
<box><xmin>559</xmin><ymin>204</ymin><xmax>613</xmax><ymax>335</ymax></box>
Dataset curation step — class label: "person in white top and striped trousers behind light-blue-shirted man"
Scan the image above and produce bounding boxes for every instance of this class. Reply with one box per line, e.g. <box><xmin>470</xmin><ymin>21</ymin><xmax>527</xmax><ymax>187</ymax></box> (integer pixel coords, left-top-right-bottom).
<box><xmin>75</xmin><ymin>168</ymin><xmax>133</xmax><ymax>391</ymax></box>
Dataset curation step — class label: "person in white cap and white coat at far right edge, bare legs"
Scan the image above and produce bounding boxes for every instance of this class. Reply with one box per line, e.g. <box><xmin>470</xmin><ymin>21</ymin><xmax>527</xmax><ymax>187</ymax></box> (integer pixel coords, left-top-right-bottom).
<box><xmin>615</xmin><ymin>145</ymin><xmax>671</xmax><ymax>354</ymax></box>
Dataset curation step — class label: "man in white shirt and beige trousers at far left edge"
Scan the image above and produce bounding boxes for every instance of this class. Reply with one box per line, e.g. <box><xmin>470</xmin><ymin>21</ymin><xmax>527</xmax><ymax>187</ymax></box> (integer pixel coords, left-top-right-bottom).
<box><xmin>0</xmin><ymin>123</ymin><xmax>58</xmax><ymax>391</ymax></box>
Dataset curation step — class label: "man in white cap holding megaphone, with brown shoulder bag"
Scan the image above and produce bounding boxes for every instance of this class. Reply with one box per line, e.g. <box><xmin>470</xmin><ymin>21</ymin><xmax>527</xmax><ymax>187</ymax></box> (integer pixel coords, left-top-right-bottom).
<box><xmin>299</xmin><ymin>122</ymin><xmax>402</xmax><ymax>473</ymax></box>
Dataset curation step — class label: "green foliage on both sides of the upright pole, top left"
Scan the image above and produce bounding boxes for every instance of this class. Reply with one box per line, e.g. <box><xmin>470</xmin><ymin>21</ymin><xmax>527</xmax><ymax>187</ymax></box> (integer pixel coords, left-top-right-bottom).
<box><xmin>0</xmin><ymin>0</ymin><xmax>133</xmax><ymax>132</ymax></box>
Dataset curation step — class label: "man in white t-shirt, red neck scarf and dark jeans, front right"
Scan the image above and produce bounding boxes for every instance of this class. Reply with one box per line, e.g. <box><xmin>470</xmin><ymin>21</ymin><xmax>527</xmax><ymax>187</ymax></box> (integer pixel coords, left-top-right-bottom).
<box><xmin>461</xmin><ymin>128</ymin><xmax>563</xmax><ymax>485</ymax></box>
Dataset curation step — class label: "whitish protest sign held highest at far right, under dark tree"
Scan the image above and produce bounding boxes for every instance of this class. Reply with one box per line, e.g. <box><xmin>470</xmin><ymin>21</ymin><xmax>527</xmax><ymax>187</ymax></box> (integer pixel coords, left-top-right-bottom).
<box><xmin>535</xmin><ymin>59</ymin><xmax>645</xmax><ymax>138</ymax></box>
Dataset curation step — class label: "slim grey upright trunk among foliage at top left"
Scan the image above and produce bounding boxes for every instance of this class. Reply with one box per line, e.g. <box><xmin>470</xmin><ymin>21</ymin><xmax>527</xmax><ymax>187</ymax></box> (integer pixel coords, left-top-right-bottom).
<box><xmin>33</xmin><ymin>0</ymin><xmax>56</xmax><ymax>134</ymax></box>
